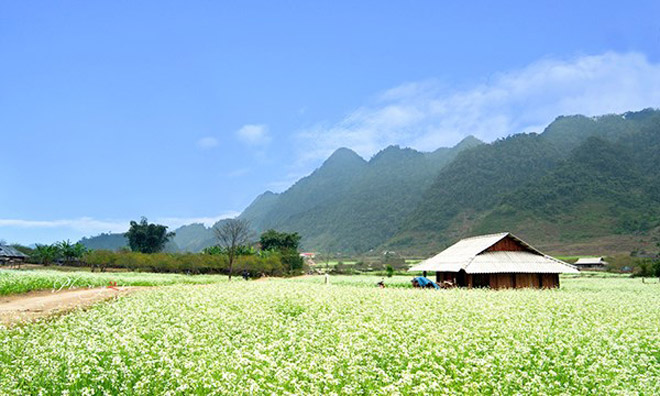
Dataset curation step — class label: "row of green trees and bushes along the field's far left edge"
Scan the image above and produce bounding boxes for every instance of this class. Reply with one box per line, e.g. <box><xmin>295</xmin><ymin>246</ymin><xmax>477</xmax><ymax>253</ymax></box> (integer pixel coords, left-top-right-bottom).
<box><xmin>10</xmin><ymin>217</ymin><xmax>303</xmax><ymax>279</ymax></box>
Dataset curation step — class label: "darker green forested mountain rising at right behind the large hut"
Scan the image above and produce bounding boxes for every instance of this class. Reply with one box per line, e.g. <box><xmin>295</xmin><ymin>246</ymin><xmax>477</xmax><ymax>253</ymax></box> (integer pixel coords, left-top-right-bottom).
<box><xmin>392</xmin><ymin>110</ymin><xmax>660</xmax><ymax>253</ymax></box>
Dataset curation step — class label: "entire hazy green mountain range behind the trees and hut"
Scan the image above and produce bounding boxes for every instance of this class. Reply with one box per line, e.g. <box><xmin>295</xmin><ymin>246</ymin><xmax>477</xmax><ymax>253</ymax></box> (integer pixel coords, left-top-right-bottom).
<box><xmin>82</xmin><ymin>109</ymin><xmax>660</xmax><ymax>256</ymax></box>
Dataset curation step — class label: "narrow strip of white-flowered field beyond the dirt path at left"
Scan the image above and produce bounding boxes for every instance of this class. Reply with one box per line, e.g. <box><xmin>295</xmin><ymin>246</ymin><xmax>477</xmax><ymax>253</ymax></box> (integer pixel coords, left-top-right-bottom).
<box><xmin>0</xmin><ymin>270</ymin><xmax>227</xmax><ymax>296</ymax></box>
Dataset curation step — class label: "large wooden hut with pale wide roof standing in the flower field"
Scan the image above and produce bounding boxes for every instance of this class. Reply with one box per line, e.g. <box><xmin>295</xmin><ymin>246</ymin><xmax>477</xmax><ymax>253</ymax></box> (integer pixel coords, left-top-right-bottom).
<box><xmin>408</xmin><ymin>232</ymin><xmax>578</xmax><ymax>289</ymax></box>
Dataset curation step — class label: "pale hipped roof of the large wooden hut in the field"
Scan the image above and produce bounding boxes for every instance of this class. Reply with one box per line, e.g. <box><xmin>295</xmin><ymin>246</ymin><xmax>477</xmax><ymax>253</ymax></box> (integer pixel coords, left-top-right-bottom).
<box><xmin>408</xmin><ymin>232</ymin><xmax>578</xmax><ymax>274</ymax></box>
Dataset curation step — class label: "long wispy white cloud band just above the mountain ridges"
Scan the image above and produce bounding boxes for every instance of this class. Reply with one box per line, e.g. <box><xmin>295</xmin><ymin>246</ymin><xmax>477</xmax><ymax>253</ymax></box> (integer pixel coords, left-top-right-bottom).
<box><xmin>298</xmin><ymin>52</ymin><xmax>660</xmax><ymax>165</ymax></box>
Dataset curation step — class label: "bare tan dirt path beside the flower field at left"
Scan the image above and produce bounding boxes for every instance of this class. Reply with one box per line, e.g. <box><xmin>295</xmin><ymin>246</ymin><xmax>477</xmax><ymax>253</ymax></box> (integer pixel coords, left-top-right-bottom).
<box><xmin>0</xmin><ymin>287</ymin><xmax>145</xmax><ymax>326</ymax></box>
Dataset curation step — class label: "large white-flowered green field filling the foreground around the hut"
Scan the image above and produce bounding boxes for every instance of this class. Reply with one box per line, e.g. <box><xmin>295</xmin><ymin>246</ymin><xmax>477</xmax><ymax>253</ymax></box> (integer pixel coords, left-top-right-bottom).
<box><xmin>0</xmin><ymin>277</ymin><xmax>660</xmax><ymax>395</ymax></box>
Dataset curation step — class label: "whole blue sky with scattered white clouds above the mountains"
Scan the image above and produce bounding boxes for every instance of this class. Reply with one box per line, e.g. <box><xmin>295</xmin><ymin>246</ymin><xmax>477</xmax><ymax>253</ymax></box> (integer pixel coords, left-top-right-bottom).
<box><xmin>0</xmin><ymin>0</ymin><xmax>660</xmax><ymax>244</ymax></box>
